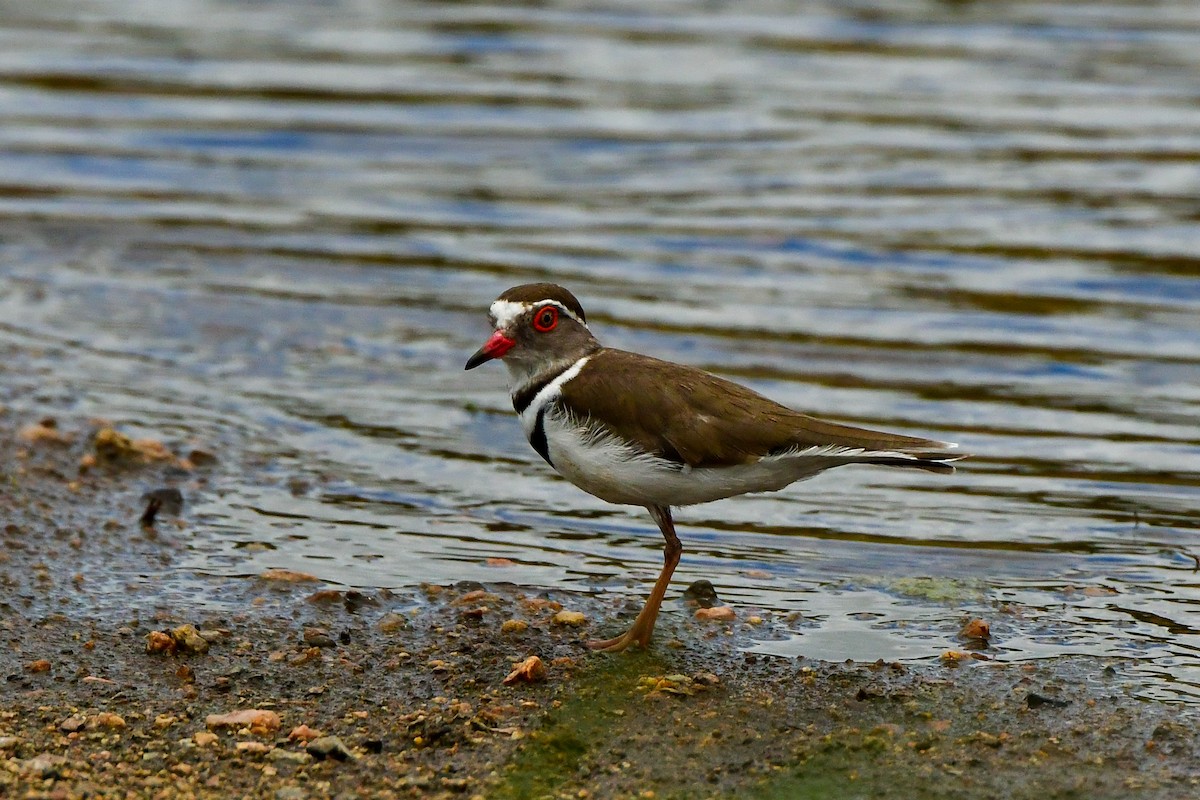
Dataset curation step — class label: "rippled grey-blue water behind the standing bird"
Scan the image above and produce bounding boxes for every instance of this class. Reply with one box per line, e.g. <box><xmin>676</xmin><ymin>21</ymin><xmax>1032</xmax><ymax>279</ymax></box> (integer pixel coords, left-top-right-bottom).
<box><xmin>0</xmin><ymin>0</ymin><xmax>1200</xmax><ymax>702</ymax></box>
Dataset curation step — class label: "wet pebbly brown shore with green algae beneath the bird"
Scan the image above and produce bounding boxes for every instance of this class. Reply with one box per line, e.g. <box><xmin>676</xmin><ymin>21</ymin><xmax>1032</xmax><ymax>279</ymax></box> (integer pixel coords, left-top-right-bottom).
<box><xmin>0</xmin><ymin>410</ymin><xmax>1200</xmax><ymax>800</ymax></box>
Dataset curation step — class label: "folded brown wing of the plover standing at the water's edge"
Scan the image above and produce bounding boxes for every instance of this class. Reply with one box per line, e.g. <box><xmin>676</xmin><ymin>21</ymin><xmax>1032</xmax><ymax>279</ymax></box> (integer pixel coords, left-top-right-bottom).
<box><xmin>562</xmin><ymin>349</ymin><xmax>961</xmax><ymax>471</ymax></box>
